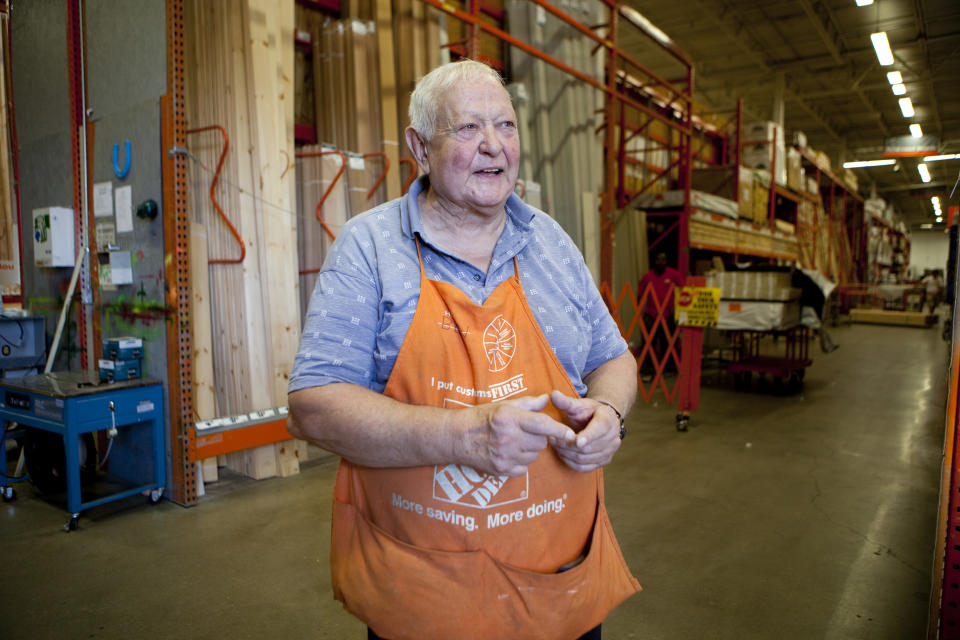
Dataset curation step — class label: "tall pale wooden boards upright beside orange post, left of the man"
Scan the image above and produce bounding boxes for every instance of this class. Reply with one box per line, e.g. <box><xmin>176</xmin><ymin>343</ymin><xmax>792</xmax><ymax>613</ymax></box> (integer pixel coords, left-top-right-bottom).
<box><xmin>184</xmin><ymin>0</ymin><xmax>300</xmax><ymax>477</ymax></box>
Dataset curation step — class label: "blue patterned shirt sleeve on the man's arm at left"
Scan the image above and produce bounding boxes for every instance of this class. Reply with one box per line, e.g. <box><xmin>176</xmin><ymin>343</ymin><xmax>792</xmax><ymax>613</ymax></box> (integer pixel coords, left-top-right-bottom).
<box><xmin>288</xmin><ymin>227</ymin><xmax>380</xmax><ymax>392</ymax></box>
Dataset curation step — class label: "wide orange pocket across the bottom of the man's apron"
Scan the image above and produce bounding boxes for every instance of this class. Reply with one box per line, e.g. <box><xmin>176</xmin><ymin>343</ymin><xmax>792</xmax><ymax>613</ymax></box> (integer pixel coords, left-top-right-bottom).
<box><xmin>330</xmin><ymin>501</ymin><xmax>640</xmax><ymax>640</ymax></box>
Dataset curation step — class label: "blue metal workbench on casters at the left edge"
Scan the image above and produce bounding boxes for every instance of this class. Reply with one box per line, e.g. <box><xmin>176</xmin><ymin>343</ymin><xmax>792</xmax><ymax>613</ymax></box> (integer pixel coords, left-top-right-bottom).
<box><xmin>0</xmin><ymin>372</ymin><xmax>166</xmax><ymax>530</ymax></box>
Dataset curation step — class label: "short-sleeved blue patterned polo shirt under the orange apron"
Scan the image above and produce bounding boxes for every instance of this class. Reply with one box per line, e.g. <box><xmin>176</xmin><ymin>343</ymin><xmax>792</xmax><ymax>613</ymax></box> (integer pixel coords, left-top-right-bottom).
<box><xmin>289</xmin><ymin>176</ymin><xmax>627</xmax><ymax>396</ymax></box>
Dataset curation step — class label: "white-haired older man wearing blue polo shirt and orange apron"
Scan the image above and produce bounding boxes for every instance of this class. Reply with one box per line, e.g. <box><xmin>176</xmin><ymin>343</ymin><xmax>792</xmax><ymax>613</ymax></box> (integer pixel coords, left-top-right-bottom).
<box><xmin>289</xmin><ymin>61</ymin><xmax>639</xmax><ymax>640</ymax></box>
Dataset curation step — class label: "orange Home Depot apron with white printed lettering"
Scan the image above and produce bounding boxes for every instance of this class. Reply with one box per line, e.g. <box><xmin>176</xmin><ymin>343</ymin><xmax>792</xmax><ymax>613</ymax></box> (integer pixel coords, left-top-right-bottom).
<box><xmin>330</xmin><ymin>244</ymin><xmax>640</xmax><ymax>640</ymax></box>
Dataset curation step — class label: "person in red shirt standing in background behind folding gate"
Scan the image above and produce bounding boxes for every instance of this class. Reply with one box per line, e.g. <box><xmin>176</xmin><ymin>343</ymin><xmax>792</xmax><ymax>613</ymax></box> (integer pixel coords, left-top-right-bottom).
<box><xmin>637</xmin><ymin>251</ymin><xmax>684</xmax><ymax>382</ymax></box>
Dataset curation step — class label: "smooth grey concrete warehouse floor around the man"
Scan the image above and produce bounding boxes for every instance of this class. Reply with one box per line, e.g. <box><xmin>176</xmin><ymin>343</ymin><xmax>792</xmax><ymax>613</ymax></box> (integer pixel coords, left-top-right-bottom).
<box><xmin>0</xmin><ymin>325</ymin><xmax>947</xmax><ymax>640</ymax></box>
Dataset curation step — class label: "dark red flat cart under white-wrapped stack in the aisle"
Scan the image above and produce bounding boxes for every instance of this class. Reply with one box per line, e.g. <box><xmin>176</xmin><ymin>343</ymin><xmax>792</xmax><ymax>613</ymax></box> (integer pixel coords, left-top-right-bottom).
<box><xmin>727</xmin><ymin>325</ymin><xmax>813</xmax><ymax>391</ymax></box>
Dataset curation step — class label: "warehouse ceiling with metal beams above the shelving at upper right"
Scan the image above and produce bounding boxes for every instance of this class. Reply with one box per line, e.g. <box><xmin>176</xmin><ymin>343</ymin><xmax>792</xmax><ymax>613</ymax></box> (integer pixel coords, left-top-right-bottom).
<box><xmin>620</xmin><ymin>0</ymin><xmax>960</xmax><ymax>226</ymax></box>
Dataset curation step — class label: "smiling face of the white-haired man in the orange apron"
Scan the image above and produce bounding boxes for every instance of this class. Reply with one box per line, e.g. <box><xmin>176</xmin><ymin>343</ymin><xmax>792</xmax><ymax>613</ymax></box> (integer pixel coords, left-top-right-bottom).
<box><xmin>427</xmin><ymin>77</ymin><xmax>520</xmax><ymax>215</ymax></box>
